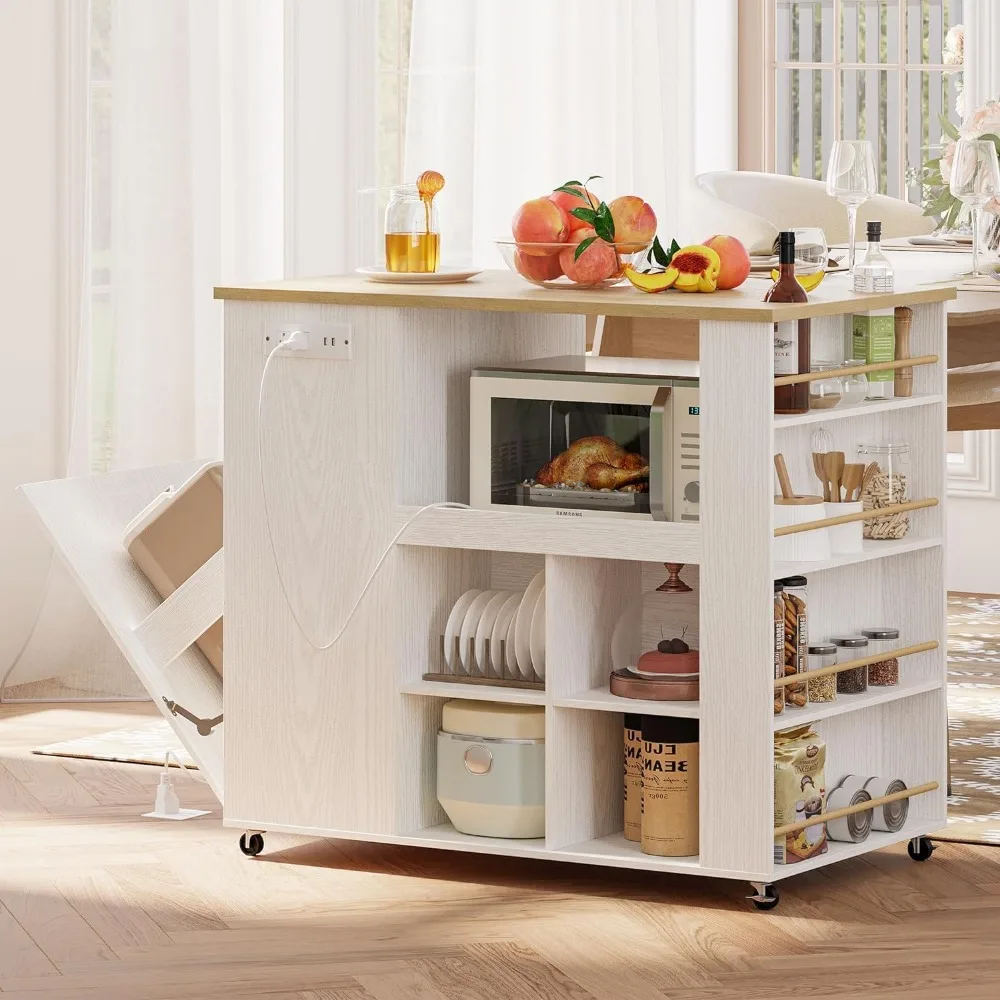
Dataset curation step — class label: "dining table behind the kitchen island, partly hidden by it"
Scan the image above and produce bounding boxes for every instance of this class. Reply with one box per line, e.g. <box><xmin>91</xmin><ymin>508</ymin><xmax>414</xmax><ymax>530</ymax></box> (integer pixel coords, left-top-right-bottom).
<box><xmin>591</xmin><ymin>239</ymin><xmax>1000</xmax><ymax>431</ymax></box>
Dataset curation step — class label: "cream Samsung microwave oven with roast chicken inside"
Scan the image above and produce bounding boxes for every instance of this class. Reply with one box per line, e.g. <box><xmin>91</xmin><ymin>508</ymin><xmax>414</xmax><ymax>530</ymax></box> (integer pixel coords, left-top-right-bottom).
<box><xmin>469</xmin><ymin>356</ymin><xmax>701</xmax><ymax>521</ymax></box>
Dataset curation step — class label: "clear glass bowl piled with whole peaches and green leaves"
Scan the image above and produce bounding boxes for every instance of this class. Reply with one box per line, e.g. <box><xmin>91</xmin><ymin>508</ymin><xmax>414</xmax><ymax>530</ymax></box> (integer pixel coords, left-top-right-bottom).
<box><xmin>496</xmin><ymin>182</ymin><xmax>656</xmax><ymax>288</ymax></box>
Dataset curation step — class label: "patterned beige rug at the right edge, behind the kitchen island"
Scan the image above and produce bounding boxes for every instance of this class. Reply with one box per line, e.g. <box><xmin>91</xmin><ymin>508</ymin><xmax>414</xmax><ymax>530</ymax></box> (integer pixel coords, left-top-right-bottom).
<box><xmin>935</xmin><ymin>594</ymin><xmax>1000</xmax><ymax>846</ymax></box>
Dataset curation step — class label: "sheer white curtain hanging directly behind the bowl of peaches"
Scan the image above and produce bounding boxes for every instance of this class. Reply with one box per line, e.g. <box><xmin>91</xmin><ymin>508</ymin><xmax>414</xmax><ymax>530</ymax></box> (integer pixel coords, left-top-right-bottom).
<box><xmin>406</xmin><ymin>0</ymin><xmax>736</xmax><ymax>266</ymax></box>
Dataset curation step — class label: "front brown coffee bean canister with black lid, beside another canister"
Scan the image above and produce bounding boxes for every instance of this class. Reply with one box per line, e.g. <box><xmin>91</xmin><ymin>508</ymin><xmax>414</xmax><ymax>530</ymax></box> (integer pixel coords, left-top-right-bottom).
<box><xmin>641</xmin><ymin>715</ymin><xmax>698</xmax><ymax>858</ymax></box>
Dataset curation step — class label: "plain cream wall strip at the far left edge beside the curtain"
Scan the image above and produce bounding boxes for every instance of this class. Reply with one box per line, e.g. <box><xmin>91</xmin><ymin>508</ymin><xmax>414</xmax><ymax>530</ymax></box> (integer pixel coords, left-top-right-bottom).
<box><xmin>0</xmin><ymin>0</ymin><xmax>62</xmax><ymax>672</ymax></box>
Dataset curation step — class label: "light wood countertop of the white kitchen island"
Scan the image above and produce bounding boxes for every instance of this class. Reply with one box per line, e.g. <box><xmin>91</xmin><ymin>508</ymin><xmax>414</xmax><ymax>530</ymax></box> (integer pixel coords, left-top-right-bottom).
<box><xmin>215</xmin><ymin>271</ymin><xmax>956</xmax><ymax>323</ymax></box>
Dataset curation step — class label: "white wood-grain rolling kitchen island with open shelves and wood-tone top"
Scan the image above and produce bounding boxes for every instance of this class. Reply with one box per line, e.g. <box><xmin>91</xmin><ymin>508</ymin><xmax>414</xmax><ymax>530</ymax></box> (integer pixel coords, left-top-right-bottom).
<box><xmin>217</xmin><ymin>271</ymin><xmax>956</xmax><ymax>912</ymax></box>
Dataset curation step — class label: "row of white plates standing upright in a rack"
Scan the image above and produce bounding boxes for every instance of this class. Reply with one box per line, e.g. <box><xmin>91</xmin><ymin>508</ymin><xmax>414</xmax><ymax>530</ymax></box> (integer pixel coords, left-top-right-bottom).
<box><xmin>444</xmin><ymin>571</ymin><xmax>545</xmax><ymax>682</ymax></box>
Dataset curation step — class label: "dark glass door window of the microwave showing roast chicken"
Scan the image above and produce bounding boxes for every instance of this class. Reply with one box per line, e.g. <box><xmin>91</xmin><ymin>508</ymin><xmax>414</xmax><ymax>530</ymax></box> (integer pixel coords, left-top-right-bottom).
<box><xmin>490</xmin><ymin>397</ymin><xmax>650</xmax><ymax>513</ymax></box>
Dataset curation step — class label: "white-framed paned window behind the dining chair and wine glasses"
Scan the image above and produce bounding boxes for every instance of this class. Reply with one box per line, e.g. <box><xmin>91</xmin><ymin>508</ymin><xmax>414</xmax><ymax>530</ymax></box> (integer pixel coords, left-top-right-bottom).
<box><xmin>765</xmin><ymin>0</ymin><xmax>963</xmax><ymax>203</ymax></box>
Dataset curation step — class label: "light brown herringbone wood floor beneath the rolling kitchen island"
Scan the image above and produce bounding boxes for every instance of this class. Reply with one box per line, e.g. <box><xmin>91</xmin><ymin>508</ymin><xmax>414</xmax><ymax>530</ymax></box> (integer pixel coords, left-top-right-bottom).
<box><xmin>0</xmin><ymin>706</ymin><xmax>1000</xmax><ymax>1000</ymax></box>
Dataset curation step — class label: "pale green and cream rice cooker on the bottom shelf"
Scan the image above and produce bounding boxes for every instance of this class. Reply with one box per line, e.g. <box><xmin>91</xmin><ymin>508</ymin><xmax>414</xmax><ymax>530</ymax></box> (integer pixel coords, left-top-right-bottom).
<box><xmin>437</xmin><ymin>700</ymin><xmax>545</xmax><ymax>838</ymax></box>
